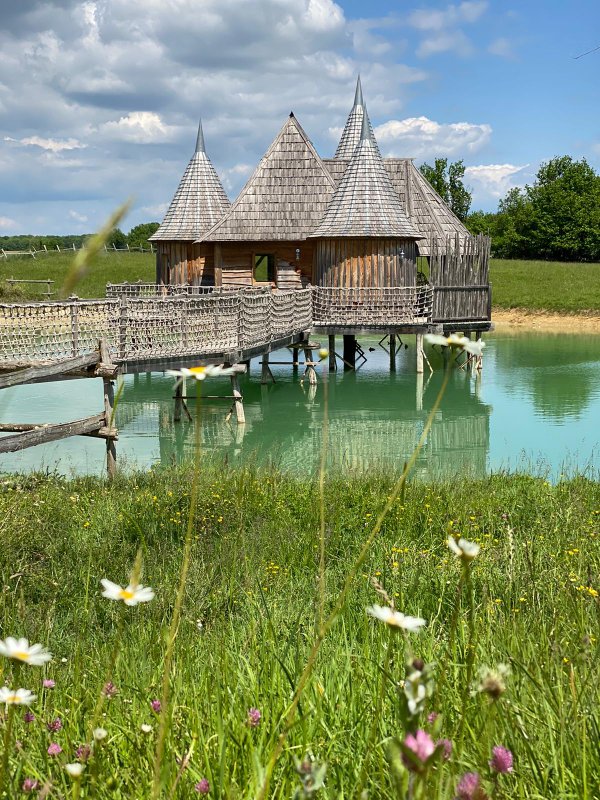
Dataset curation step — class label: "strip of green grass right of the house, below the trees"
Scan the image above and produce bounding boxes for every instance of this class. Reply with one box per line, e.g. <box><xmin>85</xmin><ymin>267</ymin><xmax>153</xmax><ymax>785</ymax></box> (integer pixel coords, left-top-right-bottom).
<box><xmin>490</xmin><ymin>259</ymin><xmax>600</xmax><ymax>314</ymax></box>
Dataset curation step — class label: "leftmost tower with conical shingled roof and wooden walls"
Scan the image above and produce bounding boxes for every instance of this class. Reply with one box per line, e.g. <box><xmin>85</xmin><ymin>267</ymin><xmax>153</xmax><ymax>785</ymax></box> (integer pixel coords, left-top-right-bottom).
<box><xmin>150</xmin><ymin>122</ymin><xmax>231</xmax><ymax>286</ymax></box>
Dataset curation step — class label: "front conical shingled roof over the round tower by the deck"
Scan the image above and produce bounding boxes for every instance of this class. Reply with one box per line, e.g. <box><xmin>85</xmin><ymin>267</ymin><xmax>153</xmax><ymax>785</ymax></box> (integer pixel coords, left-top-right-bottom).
<box><xmin>311</xmin><ymin>110</ymin><xmax>421</xmax><ymax>239</ymax></box>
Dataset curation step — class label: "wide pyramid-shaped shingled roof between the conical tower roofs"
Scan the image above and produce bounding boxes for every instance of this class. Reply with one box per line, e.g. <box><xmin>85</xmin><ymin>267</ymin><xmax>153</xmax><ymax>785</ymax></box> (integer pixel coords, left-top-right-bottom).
<box><xmin>200</xmin><ymin>114</ymin><xmax>334</xmax><ymax>242</ymax></box>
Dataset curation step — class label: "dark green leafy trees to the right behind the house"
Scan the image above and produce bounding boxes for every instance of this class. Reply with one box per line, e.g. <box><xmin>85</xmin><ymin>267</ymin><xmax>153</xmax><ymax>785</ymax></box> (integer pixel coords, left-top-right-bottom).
<box><xmin>420</xmin><ymin>156</ymin><xmax>600</xmax><ymax>261</ymax></box>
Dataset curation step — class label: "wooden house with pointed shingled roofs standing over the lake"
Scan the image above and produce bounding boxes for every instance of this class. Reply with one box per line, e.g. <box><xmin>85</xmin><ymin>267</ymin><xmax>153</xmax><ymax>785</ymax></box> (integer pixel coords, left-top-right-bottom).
<box><xmin>151</xmin><ymin>79</ymin><xmax>489</xmax><ymax>324</ymax></box>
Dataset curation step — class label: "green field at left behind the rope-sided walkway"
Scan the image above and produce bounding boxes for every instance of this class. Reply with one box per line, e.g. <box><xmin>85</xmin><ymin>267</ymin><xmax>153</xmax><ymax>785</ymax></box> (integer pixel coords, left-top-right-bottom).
<box><xmin>0</xmin><ymin>251</ymin><xmax>156</xmax><ymax>302</ymax></box>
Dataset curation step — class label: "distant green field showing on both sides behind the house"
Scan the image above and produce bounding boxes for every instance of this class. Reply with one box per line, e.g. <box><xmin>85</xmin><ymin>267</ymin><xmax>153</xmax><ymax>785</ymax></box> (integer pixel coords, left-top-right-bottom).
<box><xmin>0</xmin><ymin>252</ymin><xmax>600</xmax><ymax>314</ymax></box>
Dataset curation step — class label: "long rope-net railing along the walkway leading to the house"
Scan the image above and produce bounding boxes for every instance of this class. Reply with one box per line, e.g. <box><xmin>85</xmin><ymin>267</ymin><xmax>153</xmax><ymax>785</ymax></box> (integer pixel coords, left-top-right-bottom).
<box><xmin>0</xmin><ymin>289</ymin><xmax>312</xmax><ymax>363</ymax></box>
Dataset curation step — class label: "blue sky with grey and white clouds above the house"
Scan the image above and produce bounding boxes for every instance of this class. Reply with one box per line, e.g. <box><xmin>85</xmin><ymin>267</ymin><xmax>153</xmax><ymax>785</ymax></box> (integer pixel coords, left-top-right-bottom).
<box><xmin>0</xmin><ymin>0</ymin><xmax>600</xmax><ymax>235</ymax></box>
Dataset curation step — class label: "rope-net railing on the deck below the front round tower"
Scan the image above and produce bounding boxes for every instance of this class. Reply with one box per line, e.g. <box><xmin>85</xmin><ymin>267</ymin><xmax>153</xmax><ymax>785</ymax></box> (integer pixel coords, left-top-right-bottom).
<box><xmin>313</xmin><ymin>286</ymin><xmax>433</xmax><ymax>327</ymax></box>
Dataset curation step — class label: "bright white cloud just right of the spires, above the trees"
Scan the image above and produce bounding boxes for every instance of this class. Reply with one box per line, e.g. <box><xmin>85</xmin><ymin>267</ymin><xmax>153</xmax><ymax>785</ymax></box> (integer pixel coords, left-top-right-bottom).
<box><xmin>375</xmin><ymin>117</ymin><xmax>492</xmax><ymax>158</ymax></box>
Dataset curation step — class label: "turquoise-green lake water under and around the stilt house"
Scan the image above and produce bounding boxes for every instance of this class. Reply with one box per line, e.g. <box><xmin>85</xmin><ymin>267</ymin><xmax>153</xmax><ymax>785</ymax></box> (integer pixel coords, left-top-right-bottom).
<box><xmin>0</xmin><ymin>333</ymin><xmax>600</xmax><ymax>479</ymax></box>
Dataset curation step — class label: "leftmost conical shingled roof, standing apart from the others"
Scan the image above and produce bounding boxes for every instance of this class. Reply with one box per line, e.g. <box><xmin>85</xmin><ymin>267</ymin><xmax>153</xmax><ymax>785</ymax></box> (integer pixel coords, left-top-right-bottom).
<box><xmin>150</xmin><ymin>122</ymin><xmax>231</xmax><ymax>242</ymax></box>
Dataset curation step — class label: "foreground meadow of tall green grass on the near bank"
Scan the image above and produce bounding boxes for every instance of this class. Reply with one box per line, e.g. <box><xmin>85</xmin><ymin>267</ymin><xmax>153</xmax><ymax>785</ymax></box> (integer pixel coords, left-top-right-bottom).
<box><xmin>0</xmin><ymin>469</ymin><xmax>600</xmax><ymax>800</ymax></box>
